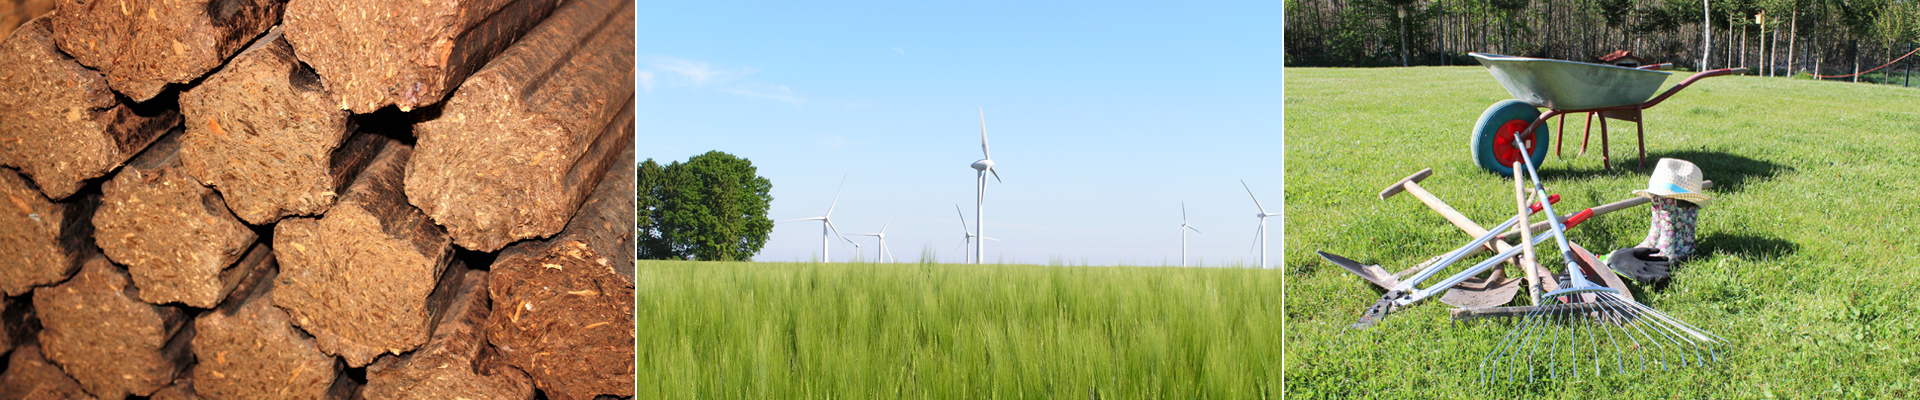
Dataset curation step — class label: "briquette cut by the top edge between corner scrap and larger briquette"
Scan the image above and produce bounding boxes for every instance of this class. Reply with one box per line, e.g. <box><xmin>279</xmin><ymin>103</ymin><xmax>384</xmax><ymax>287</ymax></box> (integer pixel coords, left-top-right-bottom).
<box><xmin>52</xmin><ymin>0</ymin><xmax>286</xmax><ymax>102</ymax></box>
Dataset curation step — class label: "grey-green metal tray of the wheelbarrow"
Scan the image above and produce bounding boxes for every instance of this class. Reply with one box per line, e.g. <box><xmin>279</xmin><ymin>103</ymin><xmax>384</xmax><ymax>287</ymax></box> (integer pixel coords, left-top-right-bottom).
<box><xmin>1469</xmin><ymin>52</ymin><xmax>1672</xmax><ymax>110</ymax></box>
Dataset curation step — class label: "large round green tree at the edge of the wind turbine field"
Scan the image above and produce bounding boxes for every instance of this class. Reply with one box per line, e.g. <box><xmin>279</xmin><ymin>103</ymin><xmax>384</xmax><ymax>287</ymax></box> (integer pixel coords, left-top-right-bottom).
<box><xmin>636</xmin><ymin>150</ymin><xmax>774</xmax><ymax>262</ymax></box>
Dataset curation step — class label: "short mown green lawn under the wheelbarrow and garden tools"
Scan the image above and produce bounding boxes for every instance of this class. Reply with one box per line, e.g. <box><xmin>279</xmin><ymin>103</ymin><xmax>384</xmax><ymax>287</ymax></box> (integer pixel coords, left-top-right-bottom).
<box><xmin>1284</xmin><ymin>67</ymin><xmax>1920</xmax><ymax>398</ymax></box>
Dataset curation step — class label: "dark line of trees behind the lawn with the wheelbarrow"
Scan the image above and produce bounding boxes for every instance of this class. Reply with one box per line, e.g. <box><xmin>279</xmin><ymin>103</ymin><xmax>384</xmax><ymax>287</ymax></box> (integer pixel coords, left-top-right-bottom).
<box><xmin>1286</xmin><ymin>0</ymin><xmax>1920</xmax><ymax>75</ymax></box>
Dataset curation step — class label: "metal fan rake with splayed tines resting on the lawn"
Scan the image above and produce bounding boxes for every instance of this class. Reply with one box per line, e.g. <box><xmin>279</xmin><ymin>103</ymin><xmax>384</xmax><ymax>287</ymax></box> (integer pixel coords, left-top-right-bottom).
<box><xmin>1480</xmin><ymin>130</ymin><xmax>1726</xmax><ymax>383</ymax></box>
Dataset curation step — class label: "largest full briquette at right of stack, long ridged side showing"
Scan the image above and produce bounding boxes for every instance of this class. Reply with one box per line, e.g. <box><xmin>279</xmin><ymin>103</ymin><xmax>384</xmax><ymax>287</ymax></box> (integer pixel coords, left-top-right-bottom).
<box><xmin>407</xmin><ymin>0</ymin><xmax>634</xmax><ymax>252</ymax></box>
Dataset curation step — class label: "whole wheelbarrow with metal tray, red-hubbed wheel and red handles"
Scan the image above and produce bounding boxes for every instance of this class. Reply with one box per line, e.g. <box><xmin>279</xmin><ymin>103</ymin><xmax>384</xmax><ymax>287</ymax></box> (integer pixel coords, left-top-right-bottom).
<box><xmin>1469</xmin><ymin>52</ymin><xmax>1745</xmax><ymax>175</ymax></box>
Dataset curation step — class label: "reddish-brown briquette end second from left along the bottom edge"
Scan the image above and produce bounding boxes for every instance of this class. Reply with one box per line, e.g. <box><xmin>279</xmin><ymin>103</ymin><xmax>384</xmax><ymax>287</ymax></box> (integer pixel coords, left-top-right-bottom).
<box><xmin>33</xmin><ymin>256</ymin><xmax>194</xmax><ymax>398</ymax></box>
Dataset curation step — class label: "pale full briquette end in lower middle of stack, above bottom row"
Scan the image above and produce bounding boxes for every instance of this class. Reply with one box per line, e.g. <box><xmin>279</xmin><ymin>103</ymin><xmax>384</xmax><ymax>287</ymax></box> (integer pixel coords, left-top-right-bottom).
<box><xmin>273</xmin><ymin>142</ymin><xmax>453</xmax><ymax>367</ymax></box>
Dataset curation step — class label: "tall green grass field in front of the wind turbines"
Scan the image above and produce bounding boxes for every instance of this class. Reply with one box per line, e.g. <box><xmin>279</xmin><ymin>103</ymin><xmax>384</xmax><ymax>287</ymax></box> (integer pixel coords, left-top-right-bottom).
<box><xmin>636</xmin><ymin>260</ymin><xmax>1281</xmax><ymax>398</ymax></box>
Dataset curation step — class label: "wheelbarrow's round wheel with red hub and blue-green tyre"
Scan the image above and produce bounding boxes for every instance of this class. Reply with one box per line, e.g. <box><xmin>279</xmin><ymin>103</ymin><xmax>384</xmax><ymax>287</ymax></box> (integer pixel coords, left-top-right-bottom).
<box><xmin>1469</xmin><ymin>100</ymin><xmax>1549</xmax><ymax>177</ymax></box>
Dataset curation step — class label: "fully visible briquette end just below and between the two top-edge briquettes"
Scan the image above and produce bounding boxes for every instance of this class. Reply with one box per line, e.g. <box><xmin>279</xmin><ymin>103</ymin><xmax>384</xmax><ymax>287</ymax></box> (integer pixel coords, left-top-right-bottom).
<box><xmin>180</xmin><ymin>27</ymin><xmax>376</xmax><ymax>225</ymax></box>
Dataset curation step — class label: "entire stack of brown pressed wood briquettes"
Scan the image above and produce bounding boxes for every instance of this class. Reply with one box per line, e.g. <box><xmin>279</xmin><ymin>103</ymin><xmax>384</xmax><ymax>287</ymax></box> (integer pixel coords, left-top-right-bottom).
<box><xmin>0</xmin><ymin>0</ymin><xmax>634</xmax><ymax>400</ymax></box>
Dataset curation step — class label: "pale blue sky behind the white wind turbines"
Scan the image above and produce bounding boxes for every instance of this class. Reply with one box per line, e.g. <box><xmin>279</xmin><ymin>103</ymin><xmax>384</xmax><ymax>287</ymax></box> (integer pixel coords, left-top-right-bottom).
<box><xmin>636</xmin><ymin>0</ymin><xmax>1283</xmax><ymax>265</ymax></box>
